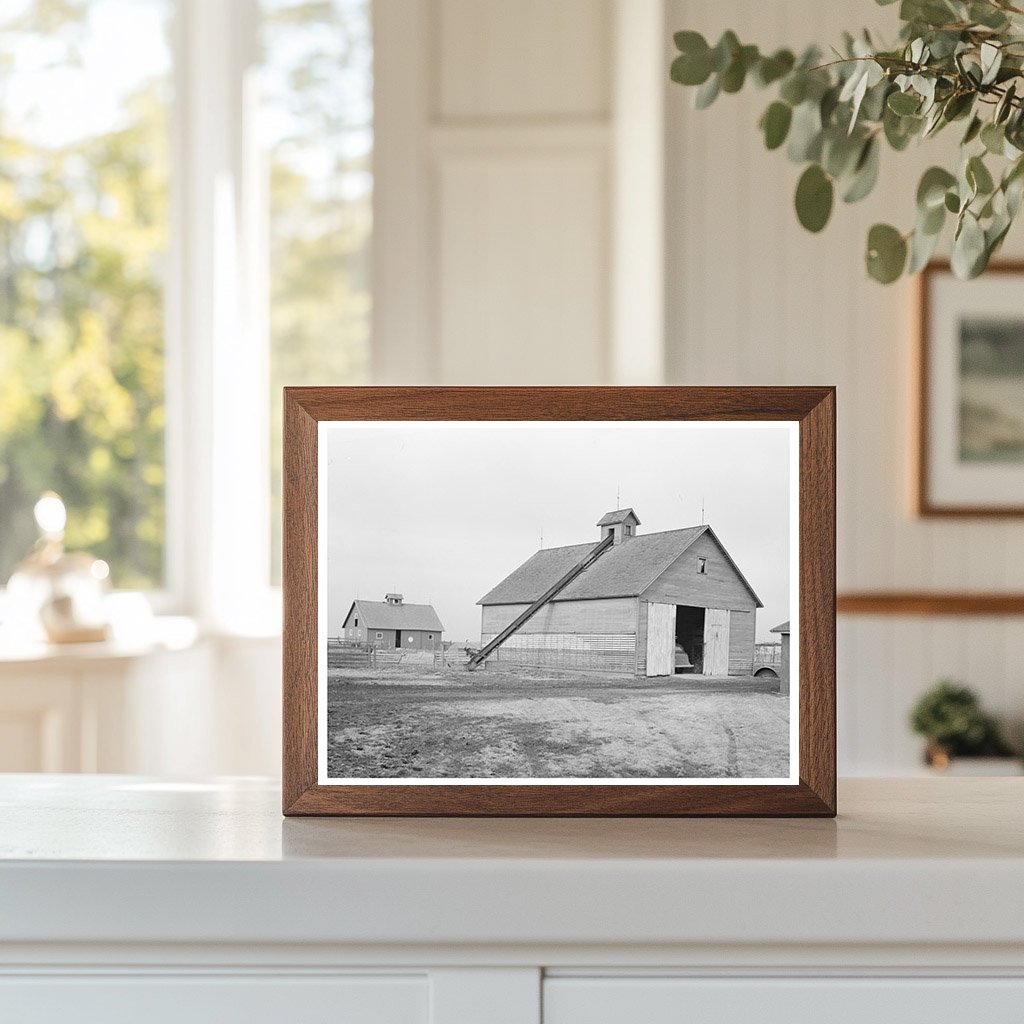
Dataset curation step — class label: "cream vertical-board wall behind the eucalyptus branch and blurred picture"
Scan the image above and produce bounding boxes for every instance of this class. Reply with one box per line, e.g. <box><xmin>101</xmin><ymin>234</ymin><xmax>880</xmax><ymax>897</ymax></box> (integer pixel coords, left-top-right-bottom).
<box><xmin>666</xmin><ymin>0</ymin><xmax>1024</xmax><ymax>773</ymax></box>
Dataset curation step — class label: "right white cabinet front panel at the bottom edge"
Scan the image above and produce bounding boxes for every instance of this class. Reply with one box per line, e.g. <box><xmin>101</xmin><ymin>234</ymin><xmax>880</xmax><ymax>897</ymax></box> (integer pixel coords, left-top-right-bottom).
<box><xmin>544</xmin><ymin>978</ymin><xmax>1024</xmax><ymax>1024</ymax></box>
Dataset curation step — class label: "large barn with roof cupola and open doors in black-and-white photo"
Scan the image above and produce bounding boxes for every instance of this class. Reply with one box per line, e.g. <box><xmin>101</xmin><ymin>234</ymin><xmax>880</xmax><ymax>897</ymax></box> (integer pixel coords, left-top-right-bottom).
<box><xmin>477</xmin><ymin>509</ymin><xmax>762</xmax><ymax>676</ymax></box>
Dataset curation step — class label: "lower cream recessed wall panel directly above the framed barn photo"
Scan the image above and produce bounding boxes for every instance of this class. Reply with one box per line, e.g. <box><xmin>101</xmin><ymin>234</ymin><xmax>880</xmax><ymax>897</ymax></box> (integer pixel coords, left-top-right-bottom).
<box><xmin>438</xmin><ymin>152</ymin><xmax>607</xmax><ymax>384</ymax></box>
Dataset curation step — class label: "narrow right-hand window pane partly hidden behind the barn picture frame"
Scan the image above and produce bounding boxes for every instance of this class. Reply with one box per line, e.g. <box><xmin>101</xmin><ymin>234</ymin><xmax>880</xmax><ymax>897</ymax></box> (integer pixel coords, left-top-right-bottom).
<box><xmin>261</xmin><ymin>0</ymin><xmax>373</xmax><ymax>583</ymax></box>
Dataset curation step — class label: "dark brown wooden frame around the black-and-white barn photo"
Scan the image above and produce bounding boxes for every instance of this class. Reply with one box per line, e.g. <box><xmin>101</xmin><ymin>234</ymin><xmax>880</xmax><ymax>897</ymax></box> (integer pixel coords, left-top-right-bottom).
<box><xmin>283</xmin><ymin>387</ymin><xmax>836</xmax><ymax>817</ymax></box>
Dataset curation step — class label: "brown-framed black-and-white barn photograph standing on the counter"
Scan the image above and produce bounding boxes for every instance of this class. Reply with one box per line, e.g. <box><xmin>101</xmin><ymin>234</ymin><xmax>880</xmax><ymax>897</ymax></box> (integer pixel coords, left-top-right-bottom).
<box><xmin>284</xmin><ymin>387</ymin><xmax>836</xmax><ymax>816</ymax></box>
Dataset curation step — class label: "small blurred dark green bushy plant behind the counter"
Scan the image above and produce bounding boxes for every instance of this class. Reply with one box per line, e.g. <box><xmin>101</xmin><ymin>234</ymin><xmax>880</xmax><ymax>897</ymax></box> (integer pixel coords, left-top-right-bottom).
<box><xmin>910</xmin><ymin>679</ymin><xmax>1019</xmax><ymax>774</ymax></box>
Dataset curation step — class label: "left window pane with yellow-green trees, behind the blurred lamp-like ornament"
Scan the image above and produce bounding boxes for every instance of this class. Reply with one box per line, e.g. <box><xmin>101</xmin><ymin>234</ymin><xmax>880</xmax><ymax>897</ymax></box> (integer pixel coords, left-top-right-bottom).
<box><xmin>0</xmin><ymin>0</ymin><xmax>173</xmax><ymax>589</ymax></box>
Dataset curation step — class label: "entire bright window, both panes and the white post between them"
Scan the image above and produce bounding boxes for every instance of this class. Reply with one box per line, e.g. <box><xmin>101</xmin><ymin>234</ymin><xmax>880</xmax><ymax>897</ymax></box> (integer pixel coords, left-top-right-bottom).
<box><xmin>0</xmin><ymin>0</ymin><xmax>373</xmax><ymax>632</ymax></box>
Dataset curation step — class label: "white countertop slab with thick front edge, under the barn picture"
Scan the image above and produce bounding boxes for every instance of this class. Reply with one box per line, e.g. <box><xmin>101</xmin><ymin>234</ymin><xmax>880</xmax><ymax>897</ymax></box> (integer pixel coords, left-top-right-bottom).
<box><xmin>0</xmin><ymin>775</ymin><xmax>1024</xmax><ymax>949</ymax></box>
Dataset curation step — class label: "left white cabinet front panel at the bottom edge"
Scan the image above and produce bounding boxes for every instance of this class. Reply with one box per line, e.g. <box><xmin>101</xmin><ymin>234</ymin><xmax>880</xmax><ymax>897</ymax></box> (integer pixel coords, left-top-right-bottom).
<box><xmin>0</xmin><ymin>975</ymin><xmax>429</xmax><ymax>1024</ymax></box>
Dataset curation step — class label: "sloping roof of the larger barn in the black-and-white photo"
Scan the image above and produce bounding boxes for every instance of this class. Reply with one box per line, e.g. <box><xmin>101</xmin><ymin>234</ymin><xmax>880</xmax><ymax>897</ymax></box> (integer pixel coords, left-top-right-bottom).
<box><xmin>476</xmin><ymin>525</ymin><xmax>761</xmax><ymax>605</ymax></box>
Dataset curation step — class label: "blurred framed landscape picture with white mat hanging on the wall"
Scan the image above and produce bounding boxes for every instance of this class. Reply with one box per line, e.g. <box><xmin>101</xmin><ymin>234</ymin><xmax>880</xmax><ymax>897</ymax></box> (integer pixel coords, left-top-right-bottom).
<box><xmin>916</xmin><ymin>263</ymin><xmax>1024</xmax><ymax>516</ymax></box>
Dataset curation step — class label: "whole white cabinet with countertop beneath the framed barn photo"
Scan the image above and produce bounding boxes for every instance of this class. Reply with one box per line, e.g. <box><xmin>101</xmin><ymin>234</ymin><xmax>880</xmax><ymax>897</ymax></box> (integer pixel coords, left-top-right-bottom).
<box><xmin>0</xmin><ymin>775</ymin><xmax>1024</xmax><ymax>1024</ymax></box>
